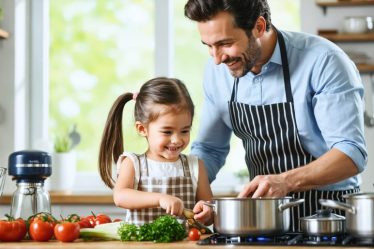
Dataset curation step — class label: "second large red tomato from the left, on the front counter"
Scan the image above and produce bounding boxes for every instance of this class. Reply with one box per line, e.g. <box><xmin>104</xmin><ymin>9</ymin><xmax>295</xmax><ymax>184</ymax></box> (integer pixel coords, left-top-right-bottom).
<box><xmin>29</xmin><ymin>218</ymin><xmax>56</xmax><ymax>241</ymax></box>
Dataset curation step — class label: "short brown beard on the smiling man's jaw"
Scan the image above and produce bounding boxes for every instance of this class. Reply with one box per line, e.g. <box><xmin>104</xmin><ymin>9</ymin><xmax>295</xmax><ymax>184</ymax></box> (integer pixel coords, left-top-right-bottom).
<box><xmin>223</xmin><ymin>35</ymin><xmax>261</xmax><ymax>78</ymax></box>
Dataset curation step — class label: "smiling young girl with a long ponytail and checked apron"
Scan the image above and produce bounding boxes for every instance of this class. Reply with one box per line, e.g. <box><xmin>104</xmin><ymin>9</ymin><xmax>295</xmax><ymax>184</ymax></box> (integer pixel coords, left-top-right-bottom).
<box><xmin>99</xmin><ymin>78</ymin><xmax>212</xmax><ymax>225</ymax></box>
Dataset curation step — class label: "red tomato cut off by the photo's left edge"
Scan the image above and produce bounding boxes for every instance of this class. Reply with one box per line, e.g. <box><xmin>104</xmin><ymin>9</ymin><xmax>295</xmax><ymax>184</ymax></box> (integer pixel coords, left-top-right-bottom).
<box><xmin>0</xmin><ymin>215</ymin><xmax>27</xmax><ymax>242</ymax></box>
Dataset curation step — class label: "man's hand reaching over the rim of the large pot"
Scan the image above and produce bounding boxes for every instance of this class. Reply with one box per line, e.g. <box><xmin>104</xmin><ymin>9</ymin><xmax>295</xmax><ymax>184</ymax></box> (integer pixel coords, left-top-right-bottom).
<box><xmin>238</xmin><ymin>175</ymin><xmax>290</xmax><ymax>198</ymax></box>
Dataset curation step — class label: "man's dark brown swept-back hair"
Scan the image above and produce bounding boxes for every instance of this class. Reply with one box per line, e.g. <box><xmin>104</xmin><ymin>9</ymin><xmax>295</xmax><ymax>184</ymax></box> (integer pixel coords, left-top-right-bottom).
<box><xmin>184</xmin><ymin>0</ymin><xmax>271</xmax><ymax>33</ymax></box>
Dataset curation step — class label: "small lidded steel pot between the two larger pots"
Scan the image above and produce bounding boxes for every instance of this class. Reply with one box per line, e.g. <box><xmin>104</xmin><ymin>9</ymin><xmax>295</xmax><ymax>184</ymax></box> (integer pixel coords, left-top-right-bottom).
<box><xmin>300</xmin><ymin>209</ymin><xmax>345</xmax><ymax>236</ymax></box>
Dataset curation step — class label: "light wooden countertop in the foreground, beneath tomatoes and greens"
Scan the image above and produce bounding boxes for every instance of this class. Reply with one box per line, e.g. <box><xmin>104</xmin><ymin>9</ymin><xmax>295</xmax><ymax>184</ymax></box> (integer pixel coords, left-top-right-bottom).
<box><xmin>0</xmin><ymin>239</ymin><xmax>373</xmax><ymax>249</ymax></box>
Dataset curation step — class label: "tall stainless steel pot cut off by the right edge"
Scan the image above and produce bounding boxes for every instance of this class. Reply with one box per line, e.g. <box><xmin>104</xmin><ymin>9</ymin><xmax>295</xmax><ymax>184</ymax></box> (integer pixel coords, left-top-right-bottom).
<box><xmin>319</xmin><ymin>193</ymin><xmax>374</xmax><ymax>238</ymax></box>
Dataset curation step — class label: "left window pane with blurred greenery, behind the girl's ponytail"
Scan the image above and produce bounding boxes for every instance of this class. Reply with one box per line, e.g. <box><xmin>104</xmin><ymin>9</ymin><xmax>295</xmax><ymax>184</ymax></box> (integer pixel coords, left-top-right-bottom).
<box><xmin>49</xmin><ymin>0</ymin><xmax>155</xmax><ymax>171</ymax></box>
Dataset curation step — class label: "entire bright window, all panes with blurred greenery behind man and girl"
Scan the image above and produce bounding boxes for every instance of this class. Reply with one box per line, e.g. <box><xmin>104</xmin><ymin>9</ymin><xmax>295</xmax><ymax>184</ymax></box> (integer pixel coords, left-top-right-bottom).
<box><xmin>49</xmin><ymin>0</ymin><xmax>300</xmax><ymax>190</ymax></box>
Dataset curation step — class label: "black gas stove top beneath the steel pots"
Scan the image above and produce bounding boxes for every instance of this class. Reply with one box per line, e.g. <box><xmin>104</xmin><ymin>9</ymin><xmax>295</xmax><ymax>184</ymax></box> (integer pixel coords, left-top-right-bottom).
<box><xmin>197</xmin><ymin>233</ymin><xmax>374</xmax><ymax>247</ymax></box>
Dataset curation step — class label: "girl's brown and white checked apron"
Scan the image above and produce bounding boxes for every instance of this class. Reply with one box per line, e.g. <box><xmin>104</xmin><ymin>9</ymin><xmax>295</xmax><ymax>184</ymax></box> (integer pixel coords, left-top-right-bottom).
<box><xmin>125</xmin><ymin>154</ymin><xmax>195</xmax><ymax>225</ymax></box>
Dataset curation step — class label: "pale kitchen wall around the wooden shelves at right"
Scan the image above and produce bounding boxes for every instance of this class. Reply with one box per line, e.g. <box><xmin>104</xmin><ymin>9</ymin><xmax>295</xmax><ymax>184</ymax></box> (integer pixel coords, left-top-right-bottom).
<box><xmin>300</xmin><ymin>0</ymin><xmax>374</xmax><ymax>192</ymax></box>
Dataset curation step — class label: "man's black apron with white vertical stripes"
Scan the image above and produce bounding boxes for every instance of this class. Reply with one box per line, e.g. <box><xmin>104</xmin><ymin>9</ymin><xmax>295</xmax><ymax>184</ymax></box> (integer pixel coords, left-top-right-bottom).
<box><xmin>228</xmin><ymin>28</ymin><xmax>359</xmax><ymax>231</ymax></box>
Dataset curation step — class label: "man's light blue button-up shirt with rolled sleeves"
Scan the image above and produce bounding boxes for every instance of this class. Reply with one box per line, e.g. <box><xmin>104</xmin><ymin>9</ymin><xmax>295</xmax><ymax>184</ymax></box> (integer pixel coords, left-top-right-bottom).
<box><xmin>191</xmin><ymin>31</ymin><xmax>367</xmax><ymax>190</ymax></box>
